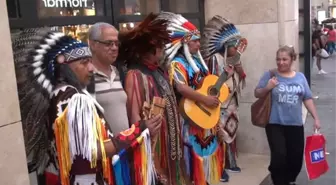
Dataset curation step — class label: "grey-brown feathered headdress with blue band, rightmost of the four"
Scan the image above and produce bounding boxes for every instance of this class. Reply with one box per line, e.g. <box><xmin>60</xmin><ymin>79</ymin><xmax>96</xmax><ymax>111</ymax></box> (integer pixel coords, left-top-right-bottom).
<box><xmin>201</xmin><ymin>15</ymin><xmax>247</xmax><ymax>58</ymax></box>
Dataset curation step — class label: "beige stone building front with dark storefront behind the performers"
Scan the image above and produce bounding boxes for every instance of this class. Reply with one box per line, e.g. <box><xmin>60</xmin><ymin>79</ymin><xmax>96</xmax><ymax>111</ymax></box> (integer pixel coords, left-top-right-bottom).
<box><xmin>0</xmin><ymin>0</ymin><xmax>302</xmax><ymax>185</ymax></box>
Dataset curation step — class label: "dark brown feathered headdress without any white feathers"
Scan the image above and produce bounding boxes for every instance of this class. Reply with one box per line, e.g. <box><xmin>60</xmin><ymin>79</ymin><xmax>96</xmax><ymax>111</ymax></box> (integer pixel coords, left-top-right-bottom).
<box><xmin>118</xmin><ymin>13</ymin><xmax>169</xmax><ymax>63</ymax></box>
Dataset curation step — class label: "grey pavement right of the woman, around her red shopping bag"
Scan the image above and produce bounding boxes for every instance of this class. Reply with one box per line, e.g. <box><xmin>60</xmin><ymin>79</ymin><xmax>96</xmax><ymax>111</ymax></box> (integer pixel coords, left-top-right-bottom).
<box><xmin>297</xmin><ymin>55</ymin><xmax>336</xmax><ymax>185</ymax></box>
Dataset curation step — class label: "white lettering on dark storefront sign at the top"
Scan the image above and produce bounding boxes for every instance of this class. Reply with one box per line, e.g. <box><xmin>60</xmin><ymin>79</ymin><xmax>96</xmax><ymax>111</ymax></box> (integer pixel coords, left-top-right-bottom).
<box><xmin>42</xmin><ymin>0</ymin><xmax>87</xmax><ymax>8</ymax></box>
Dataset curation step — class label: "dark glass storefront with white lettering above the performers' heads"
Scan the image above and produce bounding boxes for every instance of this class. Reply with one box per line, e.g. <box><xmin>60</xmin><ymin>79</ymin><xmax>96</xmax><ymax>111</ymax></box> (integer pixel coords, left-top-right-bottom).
<box><xmin>7</xmin><ymin>0</ymin><xmax>204</xmax><ymax>41</ymax></box>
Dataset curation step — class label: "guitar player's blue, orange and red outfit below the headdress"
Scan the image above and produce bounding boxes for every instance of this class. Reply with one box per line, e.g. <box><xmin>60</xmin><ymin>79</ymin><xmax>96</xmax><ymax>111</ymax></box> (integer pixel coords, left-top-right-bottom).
<box><xmin>170</xmin><ymin>55</ymin><xmax>225</xmax><ymax>185</ymax></box>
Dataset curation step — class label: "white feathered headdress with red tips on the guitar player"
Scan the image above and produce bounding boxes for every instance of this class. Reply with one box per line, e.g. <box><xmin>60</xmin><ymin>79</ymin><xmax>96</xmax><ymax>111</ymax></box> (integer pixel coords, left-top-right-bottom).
<box><xmin>157</xmin><ymin>12</ymin><xmax>208</xmax><ymax>72</ymax></box>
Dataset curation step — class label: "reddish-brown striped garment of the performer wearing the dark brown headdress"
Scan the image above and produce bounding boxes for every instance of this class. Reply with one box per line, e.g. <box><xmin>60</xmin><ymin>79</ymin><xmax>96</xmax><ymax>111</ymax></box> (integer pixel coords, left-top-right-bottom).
<box><xmin>125</xmin><ymin>64</ymin><xmax>186</xmax><ymax>185</ymax></box>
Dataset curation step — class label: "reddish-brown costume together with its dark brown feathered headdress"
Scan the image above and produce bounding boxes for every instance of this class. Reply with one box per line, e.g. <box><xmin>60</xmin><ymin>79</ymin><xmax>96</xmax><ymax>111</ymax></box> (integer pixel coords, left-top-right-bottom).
<box><xmin>119</xmin><ymin>14</ymin><xmax>186</xmax><ymax>185</ymax></box>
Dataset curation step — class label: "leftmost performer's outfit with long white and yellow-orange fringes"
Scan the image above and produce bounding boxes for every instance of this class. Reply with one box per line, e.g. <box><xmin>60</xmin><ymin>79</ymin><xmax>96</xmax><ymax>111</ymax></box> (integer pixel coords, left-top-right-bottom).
<box><xmin>46</xmin><ymin>86</ymin><xmax>155</xmax><ymax>185</ymax></box>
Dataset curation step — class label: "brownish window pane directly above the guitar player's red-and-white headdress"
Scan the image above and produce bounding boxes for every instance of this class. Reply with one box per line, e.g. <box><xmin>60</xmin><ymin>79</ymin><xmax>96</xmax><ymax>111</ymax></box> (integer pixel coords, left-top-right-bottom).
<box><xmin>169</xmin><ymin>0</ymin><xmax>199</xmax><ymax>13</ymax></box>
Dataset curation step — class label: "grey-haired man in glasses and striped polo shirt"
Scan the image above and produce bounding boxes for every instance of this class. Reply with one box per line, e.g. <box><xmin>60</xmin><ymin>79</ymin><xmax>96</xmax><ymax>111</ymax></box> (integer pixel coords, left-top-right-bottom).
<box><xmin>89</xmin><ymin>22</ymin><xmax>129</xmax><ymax>134</ymax></box>
